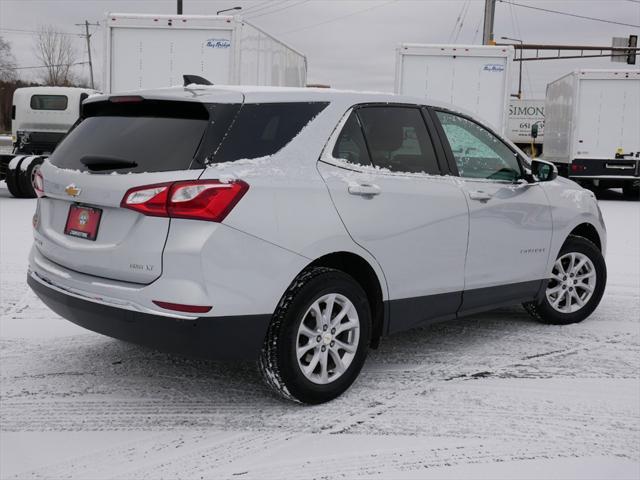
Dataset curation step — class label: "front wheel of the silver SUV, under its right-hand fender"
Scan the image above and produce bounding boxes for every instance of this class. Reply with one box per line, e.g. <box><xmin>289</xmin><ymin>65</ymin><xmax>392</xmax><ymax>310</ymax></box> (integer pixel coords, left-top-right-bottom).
<box><xmin>523</xmin><ymin>235</ymin><xmax>607</xmax><ymax>325</ymax></box>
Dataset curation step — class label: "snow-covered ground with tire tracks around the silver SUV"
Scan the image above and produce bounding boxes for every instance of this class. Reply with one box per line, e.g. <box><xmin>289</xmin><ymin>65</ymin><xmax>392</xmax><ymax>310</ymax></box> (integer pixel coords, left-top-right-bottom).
<box><xmin>0</xmin><ymin>188</ymin><xmax>640</xmax><ymax>479</ymax></box>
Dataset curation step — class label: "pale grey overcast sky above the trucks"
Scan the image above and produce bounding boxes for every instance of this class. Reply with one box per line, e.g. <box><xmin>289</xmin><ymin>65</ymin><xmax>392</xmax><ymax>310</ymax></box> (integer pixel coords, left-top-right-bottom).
<box><xmin>0</xmin><ymin>0</ymin><xmax>640</xmax><ymax>98</ymax></box>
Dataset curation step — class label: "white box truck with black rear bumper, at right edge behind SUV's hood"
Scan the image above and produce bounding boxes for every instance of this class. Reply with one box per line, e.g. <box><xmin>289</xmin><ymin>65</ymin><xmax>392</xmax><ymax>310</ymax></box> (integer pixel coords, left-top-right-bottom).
<box><xmin>544</xmin><ymin>70</ymin><xmax>640</xmax><ymax>197</ymax></box>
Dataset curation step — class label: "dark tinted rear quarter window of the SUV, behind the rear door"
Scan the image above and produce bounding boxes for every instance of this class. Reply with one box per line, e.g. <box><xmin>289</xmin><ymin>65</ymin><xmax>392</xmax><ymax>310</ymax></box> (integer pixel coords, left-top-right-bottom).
<box><xmin>212</xmin><ymin>102</ymin><xmax>328</xmax><ymax>163</ymax></box>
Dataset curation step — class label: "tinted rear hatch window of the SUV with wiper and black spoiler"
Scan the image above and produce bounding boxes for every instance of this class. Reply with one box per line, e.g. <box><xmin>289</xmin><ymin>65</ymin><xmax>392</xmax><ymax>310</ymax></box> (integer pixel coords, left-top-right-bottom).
<box><xmin>51</xmin><ymin>101</ymin><xmax>210</xmax><ymax>173</ymax></box>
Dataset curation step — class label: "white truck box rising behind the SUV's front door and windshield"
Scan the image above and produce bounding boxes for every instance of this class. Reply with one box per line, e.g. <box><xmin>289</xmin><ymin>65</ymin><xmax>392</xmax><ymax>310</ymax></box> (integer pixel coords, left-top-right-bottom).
<box><xmin>395</xmin><ymin>43</ymin><xmax>514</xmax><ymax>133</ymax></box>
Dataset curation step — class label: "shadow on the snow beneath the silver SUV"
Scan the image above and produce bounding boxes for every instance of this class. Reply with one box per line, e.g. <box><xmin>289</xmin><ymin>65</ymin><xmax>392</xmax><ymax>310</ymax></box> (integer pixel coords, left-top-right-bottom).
<box><xmin>16</xmin><ymin>307</ymin><xmax>548</xmax><ymax>407</ymax></box>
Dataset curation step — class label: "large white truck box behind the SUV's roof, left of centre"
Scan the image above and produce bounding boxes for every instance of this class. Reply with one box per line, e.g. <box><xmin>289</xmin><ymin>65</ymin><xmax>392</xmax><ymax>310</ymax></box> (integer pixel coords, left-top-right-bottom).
<box><xmin>103</xmin><ymin>13</ymin><xmax>307</xmax><ymax>93</ymax></box>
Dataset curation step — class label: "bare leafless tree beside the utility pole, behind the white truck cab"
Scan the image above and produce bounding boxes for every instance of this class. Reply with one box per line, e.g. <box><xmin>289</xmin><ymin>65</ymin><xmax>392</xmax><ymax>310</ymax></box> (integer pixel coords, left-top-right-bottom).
<box><xmin>35</xmin><ymin>25</ymin><xmax>77</xmax><ymax>86</ymax></box>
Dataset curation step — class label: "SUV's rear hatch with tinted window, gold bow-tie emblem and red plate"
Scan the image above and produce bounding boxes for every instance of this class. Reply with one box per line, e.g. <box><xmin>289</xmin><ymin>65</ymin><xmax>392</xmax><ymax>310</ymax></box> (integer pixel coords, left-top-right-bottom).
<box><xmin>35</xmin><ymin>94</ymin><xmax>242</xmax><ymax>284</ymax></box>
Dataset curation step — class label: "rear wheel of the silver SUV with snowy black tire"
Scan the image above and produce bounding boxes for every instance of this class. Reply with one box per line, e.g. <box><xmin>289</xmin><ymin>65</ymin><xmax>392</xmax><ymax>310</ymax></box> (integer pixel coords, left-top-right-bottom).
<box><xmin>259</xmin><ymin>267</ymin><xmax>371</xmax><ymax>404</ymax></box>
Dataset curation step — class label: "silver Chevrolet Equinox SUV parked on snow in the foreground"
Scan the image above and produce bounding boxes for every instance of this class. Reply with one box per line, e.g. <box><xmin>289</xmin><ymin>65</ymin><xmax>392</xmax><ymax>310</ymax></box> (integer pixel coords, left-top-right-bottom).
<box><xmin>28</xmin><ymin>86</ymin><xmax>606</xmax><ymax>403</ymax></box>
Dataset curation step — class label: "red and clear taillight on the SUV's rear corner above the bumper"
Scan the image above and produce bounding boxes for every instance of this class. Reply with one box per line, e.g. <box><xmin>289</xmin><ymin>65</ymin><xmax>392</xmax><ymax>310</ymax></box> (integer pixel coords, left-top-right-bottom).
<box><xmin>120</xmin><ymin>180</ymin><xmax>249</xmax><ymax>222</ymax></box>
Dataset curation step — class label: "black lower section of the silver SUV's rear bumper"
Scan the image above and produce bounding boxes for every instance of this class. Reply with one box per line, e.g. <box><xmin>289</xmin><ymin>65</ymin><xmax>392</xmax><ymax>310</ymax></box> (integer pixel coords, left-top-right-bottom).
<box><xmin>27</xmin><ymin>273</ymin><xmax>271</xmax><ymax>360</ymax></box>
